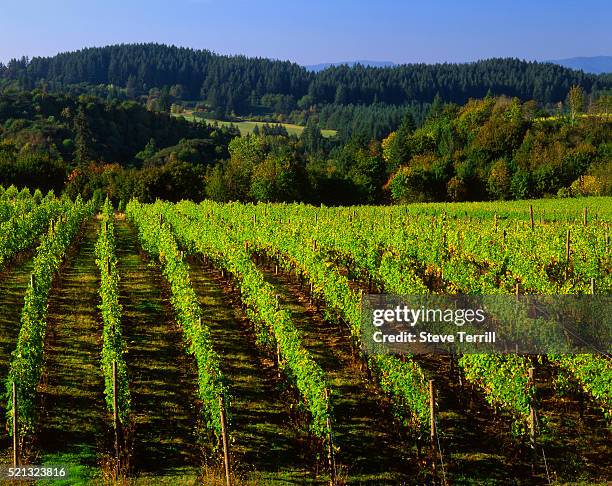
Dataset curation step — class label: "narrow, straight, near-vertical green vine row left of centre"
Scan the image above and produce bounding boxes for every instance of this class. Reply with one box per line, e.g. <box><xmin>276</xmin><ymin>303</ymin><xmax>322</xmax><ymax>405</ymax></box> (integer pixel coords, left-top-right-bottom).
<box><xmin>95</xmin><ymin>199</ymin><xmax>131</xmax><ymax>423</ymax></box>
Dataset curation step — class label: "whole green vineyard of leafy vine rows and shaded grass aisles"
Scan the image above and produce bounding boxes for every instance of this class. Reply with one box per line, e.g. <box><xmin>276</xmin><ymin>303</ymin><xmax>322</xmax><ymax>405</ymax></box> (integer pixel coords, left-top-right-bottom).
<box><xmin>0</xmin><ymin>186</ymin><xmax>612</xmax><ymax>485</ymax></box>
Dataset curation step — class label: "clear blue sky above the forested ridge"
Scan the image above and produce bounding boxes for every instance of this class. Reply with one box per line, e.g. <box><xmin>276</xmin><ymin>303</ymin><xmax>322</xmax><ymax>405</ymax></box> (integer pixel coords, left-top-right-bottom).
<box><xmin>0</xmin><ymin>0</ymin><xmax>612</xmax><ymax>64</ymax></box>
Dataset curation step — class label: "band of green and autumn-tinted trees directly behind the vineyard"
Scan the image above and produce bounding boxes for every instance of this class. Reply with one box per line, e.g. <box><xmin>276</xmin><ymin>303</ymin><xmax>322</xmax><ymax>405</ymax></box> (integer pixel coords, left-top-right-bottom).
<box><xmin>0</xmin><ymin>86</ymin><xmax>612</xmax><ymax>204</ymax></box>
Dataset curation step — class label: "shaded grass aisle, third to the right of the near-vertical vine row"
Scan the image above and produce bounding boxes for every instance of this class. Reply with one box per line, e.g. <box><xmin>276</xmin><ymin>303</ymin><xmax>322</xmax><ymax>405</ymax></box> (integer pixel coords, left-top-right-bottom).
<box><xmin>260</xmin><ymin>265</ymin><xmax>426</xmax><ymax>485</ymax></box>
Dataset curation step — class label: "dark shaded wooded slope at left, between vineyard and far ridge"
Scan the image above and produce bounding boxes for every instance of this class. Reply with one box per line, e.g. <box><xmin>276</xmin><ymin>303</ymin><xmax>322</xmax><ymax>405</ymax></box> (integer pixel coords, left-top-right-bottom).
<box><xmin>0</xmin><ymin>91</ymin><xmax>239</xmax><ymax>199</ymax></box>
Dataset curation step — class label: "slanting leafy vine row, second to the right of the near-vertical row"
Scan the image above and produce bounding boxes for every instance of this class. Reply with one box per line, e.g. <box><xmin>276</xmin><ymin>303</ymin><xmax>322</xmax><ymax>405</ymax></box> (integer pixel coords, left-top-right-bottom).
<box><xmin>157</xmin><ymin>204</ymin><xmax>332</xmax><ymax>439</ymax></box>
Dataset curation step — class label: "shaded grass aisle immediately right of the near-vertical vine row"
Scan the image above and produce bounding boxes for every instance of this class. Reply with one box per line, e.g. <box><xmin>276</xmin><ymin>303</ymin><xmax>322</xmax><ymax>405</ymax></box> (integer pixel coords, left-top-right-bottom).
<box><xmin>116</xmin><ymin>221</ymin><xmax>202</xmax><ymax>477</ymax></box>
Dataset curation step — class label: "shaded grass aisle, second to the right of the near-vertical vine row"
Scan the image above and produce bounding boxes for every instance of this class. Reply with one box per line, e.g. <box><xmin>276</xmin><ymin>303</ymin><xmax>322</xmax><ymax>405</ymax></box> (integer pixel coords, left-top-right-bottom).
<box><xmin>190</xmin><ymin>259</ymin><xmax>312</xmax><ymax>484</ymax></box>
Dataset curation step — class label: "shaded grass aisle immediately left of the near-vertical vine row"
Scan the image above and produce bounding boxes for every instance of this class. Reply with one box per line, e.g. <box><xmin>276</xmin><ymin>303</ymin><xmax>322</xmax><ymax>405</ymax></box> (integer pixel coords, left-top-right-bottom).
<box><xmin>38</xmin><ymin>221</ymin><xmax>107</xmax><ymax>484</ymax></box>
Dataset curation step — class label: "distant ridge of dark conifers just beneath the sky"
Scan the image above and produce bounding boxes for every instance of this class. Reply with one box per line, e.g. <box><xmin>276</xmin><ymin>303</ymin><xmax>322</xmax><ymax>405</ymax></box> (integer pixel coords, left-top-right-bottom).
<box><xmin>0</xmin><ymin>44</ymin><xmax>612</xmax><ymax>129</ymax></box>
